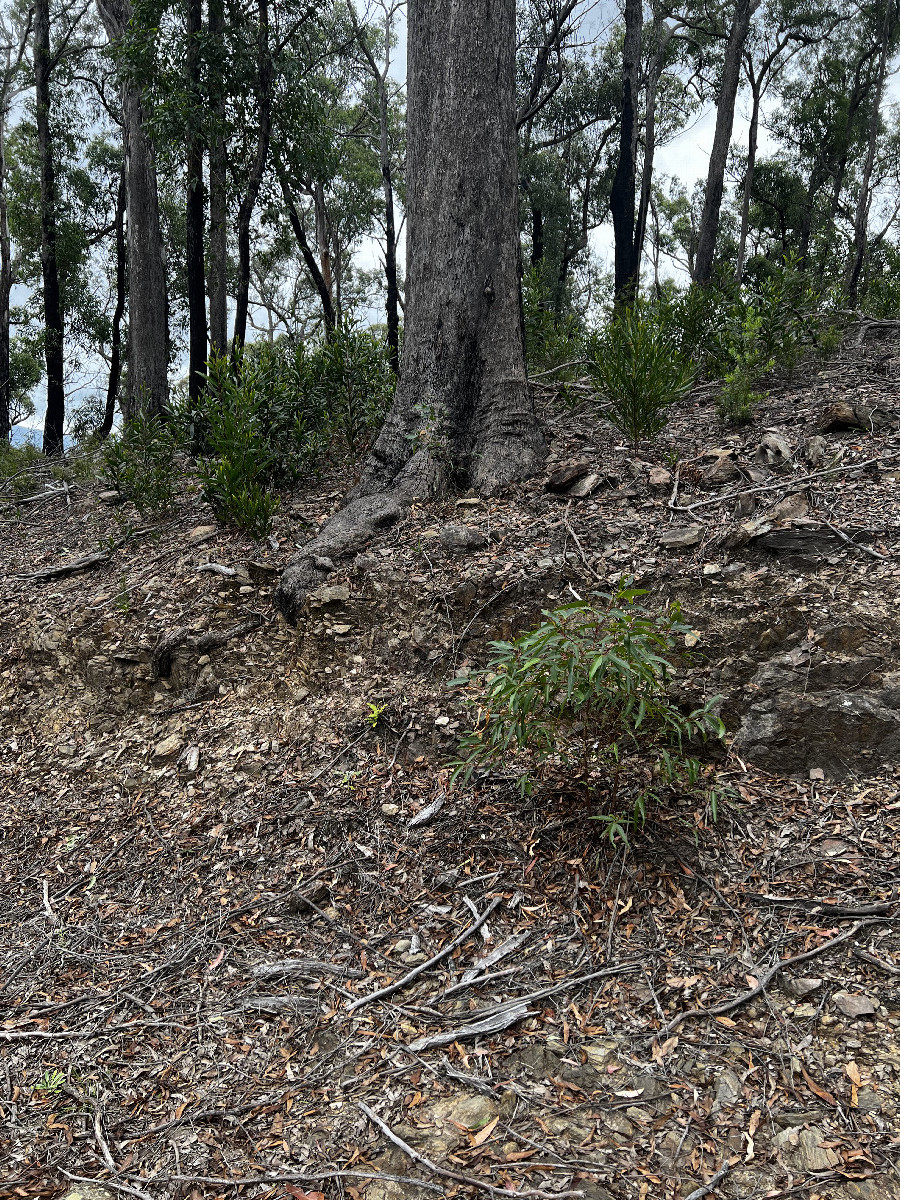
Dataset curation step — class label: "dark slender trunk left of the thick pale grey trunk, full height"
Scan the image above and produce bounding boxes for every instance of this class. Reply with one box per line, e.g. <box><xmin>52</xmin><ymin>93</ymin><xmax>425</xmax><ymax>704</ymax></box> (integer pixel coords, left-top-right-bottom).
<box><xmin>34</xmin><ymin>0</ymin><xmax>66</xmax><ymax>455</ymax></box>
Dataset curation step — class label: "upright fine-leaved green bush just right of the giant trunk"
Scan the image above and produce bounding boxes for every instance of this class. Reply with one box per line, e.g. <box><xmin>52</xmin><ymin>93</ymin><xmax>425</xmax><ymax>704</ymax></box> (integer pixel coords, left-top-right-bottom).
<box><xmin>588</xmin><ymin>305</ymin><xmax>694</xmax><ymax>444</ymax></box>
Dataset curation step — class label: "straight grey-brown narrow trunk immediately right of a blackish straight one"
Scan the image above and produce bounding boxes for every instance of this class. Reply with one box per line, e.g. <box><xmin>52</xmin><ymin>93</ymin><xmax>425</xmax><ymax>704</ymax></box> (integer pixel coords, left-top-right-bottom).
<box><xmin>208</xmin><ymin>0</ymin><xmax>228</xmax><ymax>355</ymax></box>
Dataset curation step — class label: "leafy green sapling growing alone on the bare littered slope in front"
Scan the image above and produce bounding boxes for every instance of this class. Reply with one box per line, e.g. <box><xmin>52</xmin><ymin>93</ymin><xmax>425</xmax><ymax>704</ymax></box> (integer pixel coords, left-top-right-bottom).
<box><xmin>451</xmin><ymin>588</ymin><xmax>725</xmax><ymax>840</ymax></box>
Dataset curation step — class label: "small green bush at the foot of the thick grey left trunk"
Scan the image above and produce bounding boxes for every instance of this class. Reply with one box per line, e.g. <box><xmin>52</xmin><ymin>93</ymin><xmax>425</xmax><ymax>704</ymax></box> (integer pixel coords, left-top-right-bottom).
<box><xmin>101</xmin><ymin>415</ymin><xmax>179</xmax><ymax>516</ymax></box>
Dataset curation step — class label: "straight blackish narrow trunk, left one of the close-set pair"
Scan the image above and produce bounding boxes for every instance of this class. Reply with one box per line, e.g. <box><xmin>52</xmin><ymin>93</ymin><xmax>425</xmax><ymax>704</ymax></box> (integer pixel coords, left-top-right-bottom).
<box><xmin>186</xmin><ymin>0</ymin><xmax>206</xmax><ymax>398</ymax></box>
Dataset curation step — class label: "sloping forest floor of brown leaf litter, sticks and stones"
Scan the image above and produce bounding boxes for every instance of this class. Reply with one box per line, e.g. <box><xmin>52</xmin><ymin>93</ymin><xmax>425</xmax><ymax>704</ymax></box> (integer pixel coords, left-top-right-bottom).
<box><xmin>0</xmin><ymin>335</ymin><xmax>900</xmax><ymax>1200</ymax></box>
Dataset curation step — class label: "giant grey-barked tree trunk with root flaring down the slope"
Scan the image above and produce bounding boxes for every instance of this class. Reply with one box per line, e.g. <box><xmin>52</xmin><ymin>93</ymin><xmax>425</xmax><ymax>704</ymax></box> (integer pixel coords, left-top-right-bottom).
<box><xmin>278</xmin><ymin>0</ymin><xmax>545</xmax><ymax>619</ymax></box>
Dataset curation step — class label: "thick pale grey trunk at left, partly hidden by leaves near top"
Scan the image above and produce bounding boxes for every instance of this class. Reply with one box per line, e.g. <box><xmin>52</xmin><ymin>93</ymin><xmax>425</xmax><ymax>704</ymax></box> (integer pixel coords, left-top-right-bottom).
<box><xmin>97</xmin><ymin>0</ymin><xmax>169</xmax><ymax>419</ymax></box>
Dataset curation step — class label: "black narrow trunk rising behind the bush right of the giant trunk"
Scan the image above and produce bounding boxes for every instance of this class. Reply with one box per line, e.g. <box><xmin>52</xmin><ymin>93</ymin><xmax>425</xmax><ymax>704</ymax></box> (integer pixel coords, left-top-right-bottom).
<box><xmin>610</xmin><ymin>0</ymin><xmax>643</xmax><ymax>305</ymax></box>
